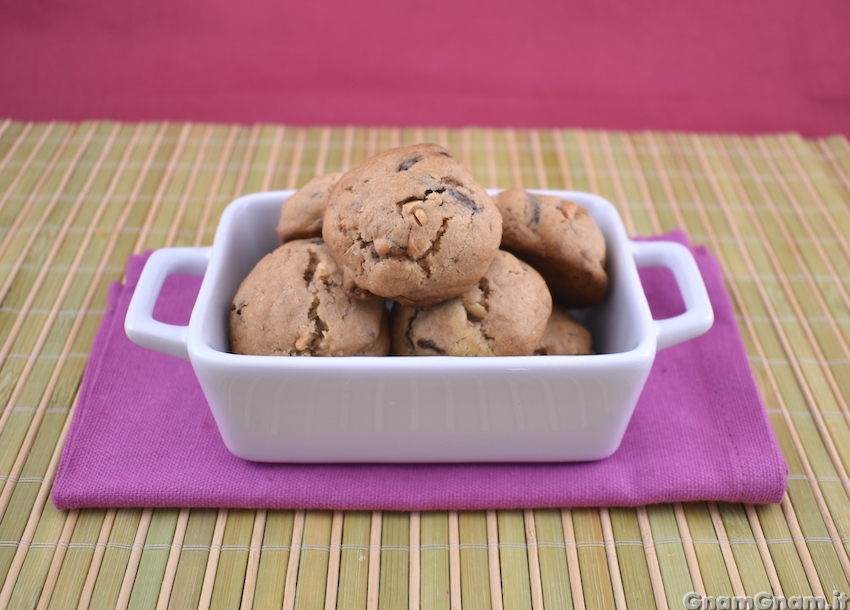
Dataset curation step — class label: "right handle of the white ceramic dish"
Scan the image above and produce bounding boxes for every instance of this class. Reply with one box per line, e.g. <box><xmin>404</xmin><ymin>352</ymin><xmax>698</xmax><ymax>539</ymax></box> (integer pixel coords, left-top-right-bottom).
<box><xmin>631</xmin><ymin>241</ymin><xmax>714</xmax><ymax>350</ymax></box>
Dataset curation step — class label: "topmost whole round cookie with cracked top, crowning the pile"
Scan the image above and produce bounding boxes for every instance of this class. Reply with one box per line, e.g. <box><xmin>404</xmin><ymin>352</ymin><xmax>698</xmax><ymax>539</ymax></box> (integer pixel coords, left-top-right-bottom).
<box><xmin>322</xmin><ymin>144</ymin><xmax>502</xmax><ymax>307</ymax></box>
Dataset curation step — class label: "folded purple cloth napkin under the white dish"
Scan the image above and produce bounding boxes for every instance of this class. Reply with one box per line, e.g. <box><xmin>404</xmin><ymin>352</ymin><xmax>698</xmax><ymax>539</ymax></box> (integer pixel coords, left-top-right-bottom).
<box><xmin>53</xmin><ymin>232</ymin><xmax>787</xmax><ymax>511</ymax></box>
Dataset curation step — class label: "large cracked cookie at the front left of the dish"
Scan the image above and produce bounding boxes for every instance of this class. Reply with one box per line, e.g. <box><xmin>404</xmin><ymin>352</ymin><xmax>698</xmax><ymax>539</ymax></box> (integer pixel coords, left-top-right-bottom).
<box><xmin>230</xmin><ymin>238</ymin><xmax>389</xmax><ymax>356</ymax></box>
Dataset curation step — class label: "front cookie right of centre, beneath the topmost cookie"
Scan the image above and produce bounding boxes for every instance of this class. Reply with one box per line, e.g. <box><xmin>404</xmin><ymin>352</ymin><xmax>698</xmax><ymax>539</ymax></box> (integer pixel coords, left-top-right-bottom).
<box><xmin>392</xmin><ymin>250</ymin><xmax>552</xmax><ymax>356</ymax></box>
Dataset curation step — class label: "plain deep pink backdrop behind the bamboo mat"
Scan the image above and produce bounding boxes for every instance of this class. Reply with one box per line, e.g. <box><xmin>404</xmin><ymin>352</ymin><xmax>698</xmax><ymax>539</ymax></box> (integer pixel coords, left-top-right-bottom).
<box><xmin>0</xmin><ymin>0</ymin><xmax>850</xmax><ymax>136</ymax></box>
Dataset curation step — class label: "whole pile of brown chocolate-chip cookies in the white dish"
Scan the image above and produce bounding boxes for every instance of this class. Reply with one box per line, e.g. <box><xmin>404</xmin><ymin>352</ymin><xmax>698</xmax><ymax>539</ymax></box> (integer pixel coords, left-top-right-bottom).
<box><xmin>230</xmin><ymin>144</ymin><xmax>608</xmax><ymax>356</ymax></box>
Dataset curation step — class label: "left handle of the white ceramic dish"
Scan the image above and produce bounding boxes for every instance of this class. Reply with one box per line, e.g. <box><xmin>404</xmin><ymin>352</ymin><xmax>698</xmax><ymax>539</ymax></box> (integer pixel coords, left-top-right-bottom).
<box><xmin>124</xmin><ymin>247</ymin><xmax>212</xmax><ymax>360</ymax></box>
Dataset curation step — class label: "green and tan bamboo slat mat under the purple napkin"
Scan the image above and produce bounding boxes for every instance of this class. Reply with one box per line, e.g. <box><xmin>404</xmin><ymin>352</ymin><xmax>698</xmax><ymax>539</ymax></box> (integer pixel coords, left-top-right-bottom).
<box><xmin>0</xmin><ymin>121</ymin><xmax>850</xmax><ymax>610</ymax></box>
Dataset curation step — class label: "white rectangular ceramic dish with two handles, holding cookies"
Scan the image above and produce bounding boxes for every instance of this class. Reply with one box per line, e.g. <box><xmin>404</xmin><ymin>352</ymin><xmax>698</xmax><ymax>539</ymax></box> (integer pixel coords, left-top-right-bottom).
<box><xmin>125</xmin><ymin>191</ymin><xmax>713</xmax><ymax>462</ymax></box>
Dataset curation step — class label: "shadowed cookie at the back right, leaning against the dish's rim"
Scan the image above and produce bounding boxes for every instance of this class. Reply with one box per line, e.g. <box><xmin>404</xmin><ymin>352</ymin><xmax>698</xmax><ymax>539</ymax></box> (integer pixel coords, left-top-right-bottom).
<box><xmin>493</xmin><ymin>189</ymin><xmax>608</xmax><ymax>308</ymax></box>
